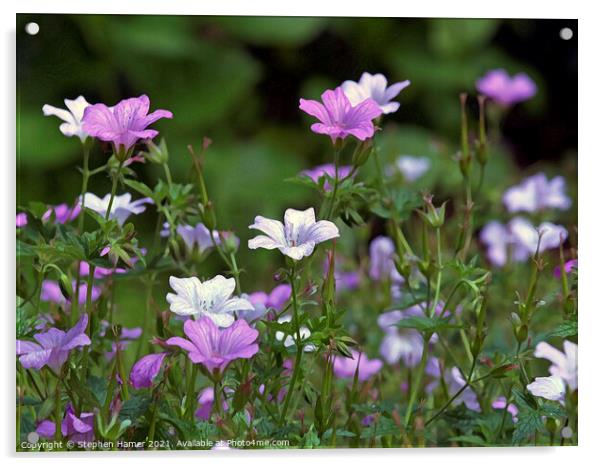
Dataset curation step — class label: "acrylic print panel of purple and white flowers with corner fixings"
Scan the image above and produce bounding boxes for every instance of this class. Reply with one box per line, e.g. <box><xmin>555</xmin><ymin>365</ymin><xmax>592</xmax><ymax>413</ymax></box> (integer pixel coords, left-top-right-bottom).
<box><xmin>15</xmin><ymin>14</ymin><xmax>578</xmax><ymax>451</ymax></box>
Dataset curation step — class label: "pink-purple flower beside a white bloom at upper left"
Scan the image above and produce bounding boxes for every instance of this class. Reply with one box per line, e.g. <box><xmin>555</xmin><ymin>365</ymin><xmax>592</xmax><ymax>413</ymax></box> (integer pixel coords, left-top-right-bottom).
<box><xmin>82</xmin><ymin>95</ymin><xmax>173</xmax><ymax>152</ymax></box>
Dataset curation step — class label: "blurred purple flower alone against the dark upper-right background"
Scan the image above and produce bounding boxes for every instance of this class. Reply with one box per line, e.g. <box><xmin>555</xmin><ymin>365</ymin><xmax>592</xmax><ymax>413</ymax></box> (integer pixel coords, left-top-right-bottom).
<box><xmin>476</xmin><ymin>69</ymin><xmax>537</xmax><ymax>107</ymax></box>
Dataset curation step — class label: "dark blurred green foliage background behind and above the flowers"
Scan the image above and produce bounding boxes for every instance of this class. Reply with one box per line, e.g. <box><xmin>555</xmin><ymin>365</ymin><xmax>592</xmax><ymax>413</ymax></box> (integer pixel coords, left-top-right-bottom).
<box><xmin>17</xmin><ymin>14</ymin><xmax>577</xmax><ymax>298</ymax></box>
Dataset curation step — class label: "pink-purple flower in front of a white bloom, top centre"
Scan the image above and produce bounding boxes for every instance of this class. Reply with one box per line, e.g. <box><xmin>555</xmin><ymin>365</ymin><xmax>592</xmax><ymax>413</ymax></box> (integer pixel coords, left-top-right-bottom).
<box><xmin>299</xmin><ymin>87</ymin><xmax>382</xmax><ymax>143</ymax></box>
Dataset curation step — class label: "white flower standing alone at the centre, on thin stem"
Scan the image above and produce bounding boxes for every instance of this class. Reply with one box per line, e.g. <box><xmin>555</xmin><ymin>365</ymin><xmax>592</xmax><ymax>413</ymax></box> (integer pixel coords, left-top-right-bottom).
<box><xmin>249</xmin><ymin>207</ymin><xmax>339</xmax><ymax>260</ymax></box>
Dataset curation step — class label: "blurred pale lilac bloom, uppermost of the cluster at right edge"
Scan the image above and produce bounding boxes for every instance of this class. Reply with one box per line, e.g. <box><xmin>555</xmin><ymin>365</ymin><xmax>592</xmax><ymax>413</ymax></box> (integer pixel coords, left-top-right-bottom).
<box><xmin>502</xmin><ymin>173</ymin><xmax>571</xmax><ymax>213</ymax></box>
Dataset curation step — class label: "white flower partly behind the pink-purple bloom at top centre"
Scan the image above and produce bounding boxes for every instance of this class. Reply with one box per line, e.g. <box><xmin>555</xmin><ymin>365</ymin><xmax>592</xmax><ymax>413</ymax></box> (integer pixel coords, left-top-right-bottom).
<box><xmin>341</xmin><ymin>73</ymin><xmax>410</xmax><ymax>113</ymax></box>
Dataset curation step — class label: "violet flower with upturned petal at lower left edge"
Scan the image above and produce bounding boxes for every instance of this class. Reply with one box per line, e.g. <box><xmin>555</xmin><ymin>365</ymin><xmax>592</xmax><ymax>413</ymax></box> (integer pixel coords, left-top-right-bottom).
<box><xmin>17</xmin><ymin>314</ymin><xmax>90</xmax><ymax>372</ymax></box>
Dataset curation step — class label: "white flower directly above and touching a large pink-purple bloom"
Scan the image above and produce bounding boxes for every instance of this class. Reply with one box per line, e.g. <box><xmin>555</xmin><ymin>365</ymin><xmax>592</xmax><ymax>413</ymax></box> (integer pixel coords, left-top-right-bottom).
<box><xmin>166</xmin><ymin>275</ymin><xmax>254</xmax><ymax>327</ymax></box>
